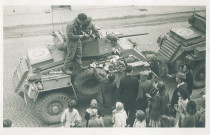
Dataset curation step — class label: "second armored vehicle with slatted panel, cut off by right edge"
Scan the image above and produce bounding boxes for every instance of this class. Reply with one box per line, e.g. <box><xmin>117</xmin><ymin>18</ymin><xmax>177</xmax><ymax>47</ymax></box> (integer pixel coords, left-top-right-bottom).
<box><xmin>158</xmin><ymin>12</ymin><xmax>206</xmax><ymax>88</ymax></box>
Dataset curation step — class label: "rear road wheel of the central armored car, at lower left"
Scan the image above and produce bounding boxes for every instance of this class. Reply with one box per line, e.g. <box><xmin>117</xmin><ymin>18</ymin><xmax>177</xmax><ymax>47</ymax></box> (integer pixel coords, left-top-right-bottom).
<box><xmin>35</xmin><ymin>92</ymin><xmax>70</xmax><ymax>124</ymax></box>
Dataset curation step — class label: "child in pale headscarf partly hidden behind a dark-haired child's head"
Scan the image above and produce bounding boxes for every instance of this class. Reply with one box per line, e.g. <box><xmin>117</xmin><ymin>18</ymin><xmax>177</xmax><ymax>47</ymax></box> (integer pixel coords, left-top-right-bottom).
<box><xmin>85</xmin><ymin>99</ymin><xmax>104</xmax><ymax>127</ymax></box>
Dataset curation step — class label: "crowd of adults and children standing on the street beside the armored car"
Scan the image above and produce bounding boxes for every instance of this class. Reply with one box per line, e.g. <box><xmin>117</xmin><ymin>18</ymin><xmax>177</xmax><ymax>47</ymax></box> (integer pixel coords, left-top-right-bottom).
<box><xmin>61</xmin><ymin>66</ymin><xmax>205</xmax><ymax>127</ymax></box>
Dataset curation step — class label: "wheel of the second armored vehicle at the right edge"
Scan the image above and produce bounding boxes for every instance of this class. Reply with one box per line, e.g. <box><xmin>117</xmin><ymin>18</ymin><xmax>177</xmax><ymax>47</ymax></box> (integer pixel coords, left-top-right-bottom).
<box><xmin>192</xmin><ymin>62</ymin><xmax>205</xmax><ymax>88</ymax></box>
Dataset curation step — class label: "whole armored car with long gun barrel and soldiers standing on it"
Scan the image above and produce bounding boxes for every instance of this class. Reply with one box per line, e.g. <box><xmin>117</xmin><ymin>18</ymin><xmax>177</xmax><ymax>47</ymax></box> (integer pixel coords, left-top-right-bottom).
<box><xmin>13</xmin><ymin>10</ymin><xmax>150</xmax><ymax>124</ymax></box>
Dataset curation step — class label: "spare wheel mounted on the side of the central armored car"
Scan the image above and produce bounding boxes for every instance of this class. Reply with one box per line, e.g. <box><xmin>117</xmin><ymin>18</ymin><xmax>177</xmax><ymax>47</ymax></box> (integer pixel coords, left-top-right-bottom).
<box><xmin>73</xmin><ymin>68</ymin><xmax>107</xmax><ymax>99</ymax></box>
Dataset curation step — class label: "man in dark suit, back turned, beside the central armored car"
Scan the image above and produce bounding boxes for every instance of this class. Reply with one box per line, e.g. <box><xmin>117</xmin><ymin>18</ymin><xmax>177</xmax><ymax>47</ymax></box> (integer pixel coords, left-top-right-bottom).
<box><xmin>119</xmin><ymin>65</ymin><xmax>139</xmax><ymax>126</ymax></box>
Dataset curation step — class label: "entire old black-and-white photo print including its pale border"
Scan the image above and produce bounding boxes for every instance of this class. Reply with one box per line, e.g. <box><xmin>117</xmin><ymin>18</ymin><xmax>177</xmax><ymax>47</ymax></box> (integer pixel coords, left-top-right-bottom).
<box><xmin>2</xmin><ymin>1</ymin><xmax>208</xmax><ymax>134</ymax></box>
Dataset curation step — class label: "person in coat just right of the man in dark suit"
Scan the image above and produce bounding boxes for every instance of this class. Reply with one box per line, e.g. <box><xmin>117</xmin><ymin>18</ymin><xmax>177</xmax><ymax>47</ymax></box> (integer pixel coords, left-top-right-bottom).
<box><xmin>136</xmin><ymin>71</ymin><xmax>153</xmax><ymax>111</ymax></box>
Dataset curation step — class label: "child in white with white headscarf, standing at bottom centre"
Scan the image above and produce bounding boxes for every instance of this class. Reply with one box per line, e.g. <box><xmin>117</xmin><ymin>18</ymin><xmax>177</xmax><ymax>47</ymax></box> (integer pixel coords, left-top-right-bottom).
<box><xmin>112</xmin><ymin>102</ymin><xmax>128</xmax><ymax>127</ymax></box>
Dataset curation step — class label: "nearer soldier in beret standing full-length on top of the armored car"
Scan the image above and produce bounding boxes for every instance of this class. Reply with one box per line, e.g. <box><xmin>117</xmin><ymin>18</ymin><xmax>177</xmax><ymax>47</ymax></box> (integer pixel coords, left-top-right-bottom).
<box><xmin>64</xmin><ymin>13</ymin><xmax>90</xmax><ymax>74</ymax></box>
